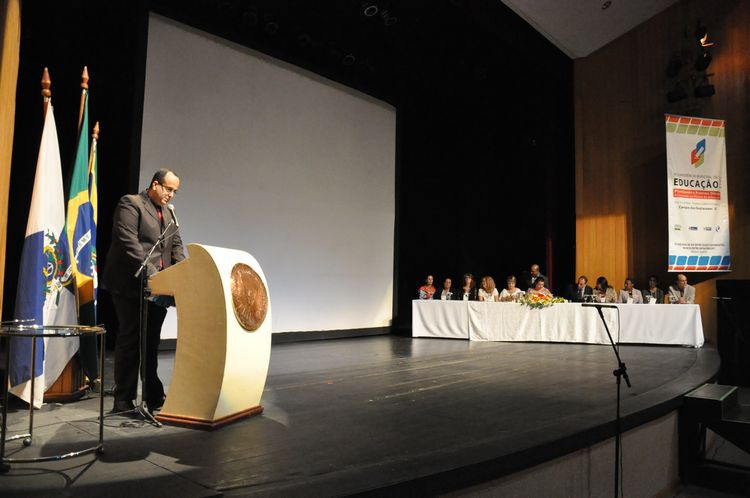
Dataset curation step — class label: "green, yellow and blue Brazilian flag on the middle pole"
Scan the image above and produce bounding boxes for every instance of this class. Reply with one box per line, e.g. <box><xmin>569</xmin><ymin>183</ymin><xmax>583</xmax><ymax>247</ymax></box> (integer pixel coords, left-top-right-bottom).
<box><xmin>65</xmin><ymin>90</ymin><xmax>98</xmax><ymax>380</ymax></box>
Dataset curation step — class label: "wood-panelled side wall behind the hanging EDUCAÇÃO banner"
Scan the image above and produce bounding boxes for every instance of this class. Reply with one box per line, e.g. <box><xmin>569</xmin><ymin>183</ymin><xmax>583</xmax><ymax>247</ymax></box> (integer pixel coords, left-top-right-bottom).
<box><xmin>574</xmin><ymin>0</ymin><xmax>750</xmax><ymax>343</ymax></box>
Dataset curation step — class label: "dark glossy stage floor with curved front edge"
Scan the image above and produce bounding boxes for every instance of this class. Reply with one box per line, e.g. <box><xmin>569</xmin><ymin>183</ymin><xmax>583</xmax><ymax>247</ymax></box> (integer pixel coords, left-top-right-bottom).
<box><xmin>0</xmin><ymin>335</ymin><xmax>719</xmax><ymax>498</ymax></box>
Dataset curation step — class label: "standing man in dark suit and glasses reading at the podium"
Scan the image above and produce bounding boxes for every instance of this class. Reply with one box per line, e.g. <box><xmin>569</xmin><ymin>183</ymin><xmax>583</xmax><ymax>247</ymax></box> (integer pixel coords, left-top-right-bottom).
<box><xmin>102</xmin><ymin>169</ymin><xmax>185</xmax><ymax>413</ymax></box>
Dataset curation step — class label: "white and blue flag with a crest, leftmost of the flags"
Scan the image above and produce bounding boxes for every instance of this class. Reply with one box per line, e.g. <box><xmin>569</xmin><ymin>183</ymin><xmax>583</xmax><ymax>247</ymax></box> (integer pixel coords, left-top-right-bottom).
<box><xmin>9</xmin><ymin>101</ymin><xmax>78</xmax><ymax>407</ymax></box>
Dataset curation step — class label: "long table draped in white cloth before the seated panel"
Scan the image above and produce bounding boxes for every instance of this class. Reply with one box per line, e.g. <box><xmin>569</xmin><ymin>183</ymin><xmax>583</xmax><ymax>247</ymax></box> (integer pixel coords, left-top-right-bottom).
<box><xmin>412</xmin><ymin>300</ymin><xmax>703</xmax><ymax>347</ymax></box>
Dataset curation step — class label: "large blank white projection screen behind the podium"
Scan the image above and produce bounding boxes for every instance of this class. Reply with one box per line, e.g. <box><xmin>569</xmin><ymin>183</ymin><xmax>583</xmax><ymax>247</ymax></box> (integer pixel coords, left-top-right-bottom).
<box><xmin>140</xmin><ymin>14</ymin><xmax>396</xmax><ymax>338</ymax></box>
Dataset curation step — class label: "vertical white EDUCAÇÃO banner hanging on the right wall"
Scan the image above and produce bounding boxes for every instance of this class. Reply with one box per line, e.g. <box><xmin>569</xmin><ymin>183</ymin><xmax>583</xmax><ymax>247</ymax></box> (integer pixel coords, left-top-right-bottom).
<box><xmin>665</xmin><ymin>114</ymin><xmax>731</xmax><ymax>272</ymax></box>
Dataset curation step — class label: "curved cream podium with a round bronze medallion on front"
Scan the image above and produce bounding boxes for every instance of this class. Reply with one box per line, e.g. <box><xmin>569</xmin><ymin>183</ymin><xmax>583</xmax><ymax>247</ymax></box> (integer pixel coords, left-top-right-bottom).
<box><xmin>149</xmin><ymin>244</ymin><xmax>271</xmax><ymax>430</ymax></box>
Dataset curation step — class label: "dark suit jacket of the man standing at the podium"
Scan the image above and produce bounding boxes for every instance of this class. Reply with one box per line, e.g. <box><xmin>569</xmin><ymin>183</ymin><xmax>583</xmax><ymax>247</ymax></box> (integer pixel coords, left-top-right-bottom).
<box><xmin>102</xmin><ymin>190</ymin><xmax>185</xmax><ymax>297</ymax></box>
